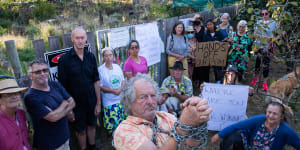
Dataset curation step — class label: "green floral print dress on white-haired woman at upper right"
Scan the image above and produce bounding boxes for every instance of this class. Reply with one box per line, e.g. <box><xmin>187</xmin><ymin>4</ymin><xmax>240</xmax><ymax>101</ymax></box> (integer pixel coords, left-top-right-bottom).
<box><xmin>227</xmin><ymin>32</ymin><xmax>252</xmax><ymax>72</ymax></box>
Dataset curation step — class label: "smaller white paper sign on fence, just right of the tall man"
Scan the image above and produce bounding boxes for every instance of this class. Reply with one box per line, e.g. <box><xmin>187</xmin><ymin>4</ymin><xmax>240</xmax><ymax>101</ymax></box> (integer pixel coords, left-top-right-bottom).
<box><xmin>108</xmin><ymin>27</ymin><xmax>130</xmax><ymax>49</ymax></box>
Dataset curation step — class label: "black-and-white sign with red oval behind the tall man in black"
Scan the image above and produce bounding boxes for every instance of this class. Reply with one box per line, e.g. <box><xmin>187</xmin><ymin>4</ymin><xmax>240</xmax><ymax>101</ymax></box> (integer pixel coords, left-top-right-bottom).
<box><xmin>44</xmin><ymin>44</ymin><xmax>91</xmax><ymax>81</ymax></box>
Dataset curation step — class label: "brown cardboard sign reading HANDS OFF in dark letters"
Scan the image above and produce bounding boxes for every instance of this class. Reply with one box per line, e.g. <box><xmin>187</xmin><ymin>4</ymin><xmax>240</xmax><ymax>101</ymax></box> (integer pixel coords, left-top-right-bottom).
<box><xmin>195</xmin><ymin>42</ymin><xmax>229</xmax><ymax>67</ymax></box>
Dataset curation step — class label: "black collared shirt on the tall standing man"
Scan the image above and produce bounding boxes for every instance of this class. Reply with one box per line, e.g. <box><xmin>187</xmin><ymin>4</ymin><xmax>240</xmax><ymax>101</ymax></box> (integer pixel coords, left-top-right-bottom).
<box><xmin>58</xmin><ymin>48</ymin><xmax>99</xmax><ymax>109</ymax></box>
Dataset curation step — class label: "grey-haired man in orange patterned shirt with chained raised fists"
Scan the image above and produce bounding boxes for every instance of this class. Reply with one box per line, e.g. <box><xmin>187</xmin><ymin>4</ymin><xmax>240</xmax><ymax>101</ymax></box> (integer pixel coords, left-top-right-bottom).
<box><xmin>114</xmin><ymin>74</ymin><xmax>212</xmax><ymax>150</ymax></box>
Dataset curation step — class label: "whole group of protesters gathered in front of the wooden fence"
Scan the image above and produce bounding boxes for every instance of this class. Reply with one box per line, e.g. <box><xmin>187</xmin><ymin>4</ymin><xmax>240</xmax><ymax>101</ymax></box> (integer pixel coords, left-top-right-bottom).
<box><xmin>0</xmin><ymin>9</ymin><xmax>300</xmax><ymax>150</ymax></box>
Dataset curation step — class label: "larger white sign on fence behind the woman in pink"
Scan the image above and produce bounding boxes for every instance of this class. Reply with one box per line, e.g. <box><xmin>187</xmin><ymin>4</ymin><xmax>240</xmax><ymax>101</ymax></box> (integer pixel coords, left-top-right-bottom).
<box><xmin>135</xmin><ymin>22</ymin><xmax>164</xmax><ymax>66</ymax></box>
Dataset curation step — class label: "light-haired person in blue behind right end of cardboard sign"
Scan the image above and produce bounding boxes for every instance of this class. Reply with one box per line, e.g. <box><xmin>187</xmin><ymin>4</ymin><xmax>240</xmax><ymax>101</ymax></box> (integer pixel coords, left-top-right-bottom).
<box><xmin>217</xmin><ymin>13</ymin><xmax>233</xmax><ymax>39</ymax></box>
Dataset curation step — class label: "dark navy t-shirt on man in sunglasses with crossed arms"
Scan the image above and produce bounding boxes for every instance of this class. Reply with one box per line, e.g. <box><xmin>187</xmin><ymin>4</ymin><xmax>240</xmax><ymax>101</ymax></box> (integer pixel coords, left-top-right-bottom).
<box><xmin>24</xmin><ymin>82</ymin><xmax>70</xmax><ymax>150</ymax></box>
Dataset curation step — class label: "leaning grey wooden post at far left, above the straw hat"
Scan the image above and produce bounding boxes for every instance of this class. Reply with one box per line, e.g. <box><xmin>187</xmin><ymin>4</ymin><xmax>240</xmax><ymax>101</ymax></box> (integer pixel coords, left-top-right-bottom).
<box><xmin>5</xmin><ymin>40</ymin><xmax>23</xmax><ymax>79</ymax></box>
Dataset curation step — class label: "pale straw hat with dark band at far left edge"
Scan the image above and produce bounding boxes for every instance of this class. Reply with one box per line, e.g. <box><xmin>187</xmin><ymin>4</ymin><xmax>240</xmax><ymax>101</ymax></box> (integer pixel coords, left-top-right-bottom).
<box><xmin>0</xmin><ymin>79</ymin><xmax>27</xmax><ymax>94</ymax></box>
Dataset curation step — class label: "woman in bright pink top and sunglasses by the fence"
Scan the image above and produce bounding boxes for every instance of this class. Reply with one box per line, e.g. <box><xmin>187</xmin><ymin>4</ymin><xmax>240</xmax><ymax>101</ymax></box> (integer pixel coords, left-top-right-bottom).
<box><xmin>123</xmin><ymin>40</ymin><xmax>148</xmax><ymax>80</ymax></box>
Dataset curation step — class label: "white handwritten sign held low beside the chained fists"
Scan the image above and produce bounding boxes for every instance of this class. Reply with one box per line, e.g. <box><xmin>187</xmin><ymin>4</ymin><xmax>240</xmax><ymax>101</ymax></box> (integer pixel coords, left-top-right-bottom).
<box><xmin>201</xmin><ymin>83</ymin><xmax>249</xmax><ymax>131</ymax></box>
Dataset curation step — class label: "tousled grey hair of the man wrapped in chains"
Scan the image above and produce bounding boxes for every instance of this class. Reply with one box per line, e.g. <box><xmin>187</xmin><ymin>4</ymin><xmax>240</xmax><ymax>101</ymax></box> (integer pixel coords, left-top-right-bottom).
<box><xmin>120</xmin><ymin>73</ymin><xmax>160</xmax><ymax>115</ymax></box>
